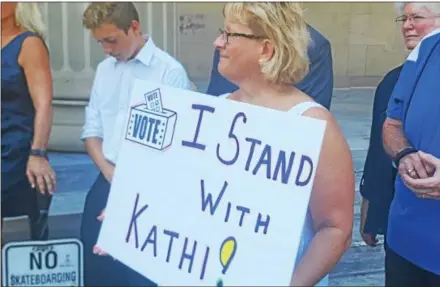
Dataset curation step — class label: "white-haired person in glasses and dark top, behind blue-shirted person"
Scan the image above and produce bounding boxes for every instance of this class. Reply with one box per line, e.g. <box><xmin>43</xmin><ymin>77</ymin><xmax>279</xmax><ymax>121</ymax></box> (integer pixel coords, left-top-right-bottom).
<box><xmin>360</xmin><ymin>2</ymin><xmax>440</xmax><ymax>248</ymax></box>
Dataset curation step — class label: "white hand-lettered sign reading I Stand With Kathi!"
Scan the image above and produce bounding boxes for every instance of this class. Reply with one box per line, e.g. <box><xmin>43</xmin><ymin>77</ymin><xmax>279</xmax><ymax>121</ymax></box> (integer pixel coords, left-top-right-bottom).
<box><xmin>98</xmin><ymin>80</ymin><xmax>325</xmax><ymax>286</ymax></box>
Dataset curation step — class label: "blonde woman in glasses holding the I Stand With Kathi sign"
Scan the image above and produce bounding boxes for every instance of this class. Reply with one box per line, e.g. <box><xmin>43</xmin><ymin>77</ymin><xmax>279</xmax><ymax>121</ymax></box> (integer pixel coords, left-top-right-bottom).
<box><xmin>214</xmin><ymin>2</ymin><xmax>354</xmax><ymax>286</ymax></box>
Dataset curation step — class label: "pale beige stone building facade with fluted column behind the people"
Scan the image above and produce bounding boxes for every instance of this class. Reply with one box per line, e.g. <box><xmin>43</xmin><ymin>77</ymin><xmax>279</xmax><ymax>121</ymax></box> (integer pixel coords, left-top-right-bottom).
<box><xmin>41</xmin><ymin>2</ymin><xmax>407</xmax><ymax>151</ymax></box>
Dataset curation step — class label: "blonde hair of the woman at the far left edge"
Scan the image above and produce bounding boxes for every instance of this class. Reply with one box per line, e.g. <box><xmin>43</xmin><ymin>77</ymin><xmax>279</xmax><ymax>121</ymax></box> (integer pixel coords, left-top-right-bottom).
<box><xmin>15</xmin><ymin>2</ymin><xmax>46</xmax><ymax>39</ymax></box>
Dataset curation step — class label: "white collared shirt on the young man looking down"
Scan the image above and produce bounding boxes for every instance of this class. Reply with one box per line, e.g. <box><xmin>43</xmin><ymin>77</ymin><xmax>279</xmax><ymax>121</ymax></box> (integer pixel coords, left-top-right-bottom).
<box><xmin>81</xmin><ymin>37</ymin><xmax>191</xmax><ymax>163</ymax></box>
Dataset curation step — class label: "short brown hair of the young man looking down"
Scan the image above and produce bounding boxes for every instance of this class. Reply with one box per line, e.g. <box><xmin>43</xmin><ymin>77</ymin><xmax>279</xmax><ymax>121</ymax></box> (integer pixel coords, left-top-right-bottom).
<box><xmin>83</xmin><ymin>2</ymin><xmax>139</xmax><ymax>32</ymax></box>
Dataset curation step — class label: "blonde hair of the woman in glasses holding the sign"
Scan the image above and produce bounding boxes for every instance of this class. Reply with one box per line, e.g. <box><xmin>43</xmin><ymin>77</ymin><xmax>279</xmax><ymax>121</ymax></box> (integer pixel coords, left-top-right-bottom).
<box><xmin>223</xmin><ymin>2</ymin><xmax>310</xmax><ymax>84</ymax></box>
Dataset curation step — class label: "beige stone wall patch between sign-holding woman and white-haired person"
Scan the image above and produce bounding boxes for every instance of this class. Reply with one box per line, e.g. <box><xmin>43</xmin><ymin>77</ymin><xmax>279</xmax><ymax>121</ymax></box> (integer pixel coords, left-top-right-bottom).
<box><xmin>304</xmin><ymin>2</ymin><xmax>408</xmax><ymax>87</ymax></box>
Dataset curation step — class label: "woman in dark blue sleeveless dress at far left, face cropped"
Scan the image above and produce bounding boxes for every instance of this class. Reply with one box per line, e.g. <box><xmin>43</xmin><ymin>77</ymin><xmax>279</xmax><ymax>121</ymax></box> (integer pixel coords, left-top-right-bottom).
<box><xmin>1</xmin><ymin>2</ymin><xmax>55</xmax><ymax>243</ymax></box>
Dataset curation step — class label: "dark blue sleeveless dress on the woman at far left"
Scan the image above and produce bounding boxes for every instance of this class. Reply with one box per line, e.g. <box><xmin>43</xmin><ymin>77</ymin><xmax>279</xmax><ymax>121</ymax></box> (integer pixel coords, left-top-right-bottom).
<box><xmin>1</xmin><ymin>32</ymin><xmax>37</xmax><ymax>217</ymax></box>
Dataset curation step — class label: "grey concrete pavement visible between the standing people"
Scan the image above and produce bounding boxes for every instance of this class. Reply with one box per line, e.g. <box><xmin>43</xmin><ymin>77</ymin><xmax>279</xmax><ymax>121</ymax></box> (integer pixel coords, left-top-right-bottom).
<box><xmin>5</xmin><ymin>89</ymin><xmax>383</xmax><ymax>286</ymax></box>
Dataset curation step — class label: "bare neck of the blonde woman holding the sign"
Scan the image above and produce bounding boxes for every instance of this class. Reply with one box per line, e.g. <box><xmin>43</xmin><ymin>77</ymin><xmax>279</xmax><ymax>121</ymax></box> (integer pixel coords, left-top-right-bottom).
<box><xmin>238</xmin><ymin>76</ymin><xmax>294</xmax><ymax>102</ymax></box>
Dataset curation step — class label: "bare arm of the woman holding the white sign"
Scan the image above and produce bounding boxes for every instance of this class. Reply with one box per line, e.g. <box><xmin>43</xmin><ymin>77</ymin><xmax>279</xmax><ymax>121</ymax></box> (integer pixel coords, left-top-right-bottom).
<box><xmin>291</xmin><ymin>108</ymin><xmax>355</xmax><ymax>286</ymax></box>
